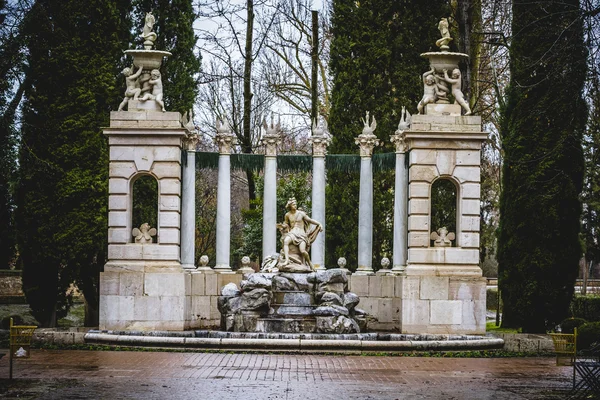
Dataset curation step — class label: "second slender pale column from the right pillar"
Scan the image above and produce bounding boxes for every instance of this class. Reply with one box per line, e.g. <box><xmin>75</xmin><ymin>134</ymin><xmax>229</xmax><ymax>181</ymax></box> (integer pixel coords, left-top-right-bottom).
<box><xmin>355</xmin><ymin>112</ymin><xmax>379</xmax><ymax>275</ymax></box>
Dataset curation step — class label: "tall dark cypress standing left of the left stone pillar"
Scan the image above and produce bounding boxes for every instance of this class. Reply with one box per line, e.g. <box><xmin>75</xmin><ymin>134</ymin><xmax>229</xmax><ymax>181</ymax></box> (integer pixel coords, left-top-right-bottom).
<box><xmin>17</xmin><ymin>0</ymin><xmax>130</xmax><ymax>326</ymax></box>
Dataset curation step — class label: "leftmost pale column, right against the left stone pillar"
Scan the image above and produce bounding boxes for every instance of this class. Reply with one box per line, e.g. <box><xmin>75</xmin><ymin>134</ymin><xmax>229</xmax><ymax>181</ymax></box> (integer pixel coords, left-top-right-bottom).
<box><xmin>181</xmin><ymin>131</ymin><xmax>200</xmax><ymax>269</ymax></box>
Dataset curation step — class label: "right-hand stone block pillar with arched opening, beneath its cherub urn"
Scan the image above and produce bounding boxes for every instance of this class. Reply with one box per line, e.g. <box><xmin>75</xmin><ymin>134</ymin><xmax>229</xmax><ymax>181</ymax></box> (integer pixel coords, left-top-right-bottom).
<box><xmin>401</xmin><ymin>104</ymin><xmax>487</xmax><ymax>333</ymax></box>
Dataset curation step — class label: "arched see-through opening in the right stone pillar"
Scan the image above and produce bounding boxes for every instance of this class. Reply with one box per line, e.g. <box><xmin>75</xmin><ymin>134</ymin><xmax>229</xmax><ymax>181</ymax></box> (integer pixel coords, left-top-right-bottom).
<box><xmin>429</xmin><ymin>177</ymin><xmax>458</xmax><ymax>247</ymax></box>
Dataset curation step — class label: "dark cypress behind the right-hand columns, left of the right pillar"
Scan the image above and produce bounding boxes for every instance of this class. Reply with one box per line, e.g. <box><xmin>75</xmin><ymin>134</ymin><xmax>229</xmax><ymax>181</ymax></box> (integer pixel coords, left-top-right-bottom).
<box><xmin>326</xmin><ymin>0</ymin><xmax>449</xmax><ymax>266</ymax></box>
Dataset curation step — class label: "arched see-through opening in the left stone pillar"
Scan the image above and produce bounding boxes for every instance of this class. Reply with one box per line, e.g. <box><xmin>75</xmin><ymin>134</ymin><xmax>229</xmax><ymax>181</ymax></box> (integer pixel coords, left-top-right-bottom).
<box><xmin>131</xmin><ymin>174</ymin><xmax>158</xmax><ymax>243</ymax></box>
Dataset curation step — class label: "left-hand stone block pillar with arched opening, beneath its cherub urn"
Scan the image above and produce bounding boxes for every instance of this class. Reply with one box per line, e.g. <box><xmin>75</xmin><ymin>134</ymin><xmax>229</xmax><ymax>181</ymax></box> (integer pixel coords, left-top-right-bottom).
<box><xmin>100</xmin><ymin>111</ymin><xmax>191</xmax><ymax>330</ymax></box>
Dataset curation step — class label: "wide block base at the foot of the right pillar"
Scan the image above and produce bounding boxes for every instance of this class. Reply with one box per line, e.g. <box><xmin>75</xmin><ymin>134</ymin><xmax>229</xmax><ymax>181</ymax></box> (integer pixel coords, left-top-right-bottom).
<box><xmin>400</xmin><ymin>276</ymin><xmax>486</xmax><ymax>334</ymax></box>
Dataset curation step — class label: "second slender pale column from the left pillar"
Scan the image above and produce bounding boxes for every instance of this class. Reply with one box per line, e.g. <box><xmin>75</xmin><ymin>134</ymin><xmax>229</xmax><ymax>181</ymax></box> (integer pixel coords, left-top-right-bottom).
<box><xmin>215</xmin><ymin>121</ymin><xmax>235</xmax><ymax>273</ymax></box>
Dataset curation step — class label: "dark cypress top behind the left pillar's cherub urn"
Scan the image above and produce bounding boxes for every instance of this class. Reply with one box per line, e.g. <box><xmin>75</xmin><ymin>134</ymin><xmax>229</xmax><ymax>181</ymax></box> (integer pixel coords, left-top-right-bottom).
<box><xmin>134</xmin><ymin>0</ymin><xmax>201</xmax><ymax>113</ymax></box>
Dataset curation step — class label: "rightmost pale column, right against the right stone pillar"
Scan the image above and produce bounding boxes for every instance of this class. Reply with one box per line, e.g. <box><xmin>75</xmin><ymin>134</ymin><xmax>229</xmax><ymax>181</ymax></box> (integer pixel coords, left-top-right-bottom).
<box><xmin>390</xmin><ymin>130</ymin><xmax>408</xmax><ymax>274</ymax></box>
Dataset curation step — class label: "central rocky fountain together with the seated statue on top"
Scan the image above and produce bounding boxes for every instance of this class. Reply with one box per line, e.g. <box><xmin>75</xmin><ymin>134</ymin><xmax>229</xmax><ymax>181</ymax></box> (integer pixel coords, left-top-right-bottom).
<box><xmin>218</xmin><ymin>198</ymin><xmax>366</xmax><ymax>334</ymax></box>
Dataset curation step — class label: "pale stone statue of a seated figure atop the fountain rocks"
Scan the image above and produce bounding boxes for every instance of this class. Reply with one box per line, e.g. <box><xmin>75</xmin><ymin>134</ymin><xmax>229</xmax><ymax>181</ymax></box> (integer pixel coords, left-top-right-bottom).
<box><xmin>277</xmin><ymin>197</ymin><xmax>323</xmax><ymax>272</ymax></box>
